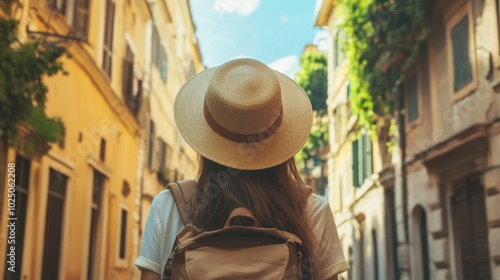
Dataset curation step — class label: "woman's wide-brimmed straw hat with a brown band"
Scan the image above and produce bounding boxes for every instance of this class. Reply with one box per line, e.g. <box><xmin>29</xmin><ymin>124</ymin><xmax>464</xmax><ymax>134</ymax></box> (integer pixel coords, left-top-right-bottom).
<box><xmin>174</xmin><ymin>59</ymin><xmax>312</xmax><ymax>170</ymax></box>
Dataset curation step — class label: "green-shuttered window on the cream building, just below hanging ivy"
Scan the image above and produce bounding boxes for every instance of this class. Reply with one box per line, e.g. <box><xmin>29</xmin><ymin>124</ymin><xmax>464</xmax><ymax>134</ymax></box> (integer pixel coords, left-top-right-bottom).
<box><xmin>352</xmin><ymin>134</ymin><xmax>372</xmax><ymax>187</ymax></box>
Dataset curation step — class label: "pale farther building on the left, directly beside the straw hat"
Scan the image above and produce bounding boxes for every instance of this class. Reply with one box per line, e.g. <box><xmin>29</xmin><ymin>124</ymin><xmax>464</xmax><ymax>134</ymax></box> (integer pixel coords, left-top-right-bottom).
<box><xmin>136</xmin><ymin>0</ymin><xmax>204</xmax><ymax>273</ymax></box>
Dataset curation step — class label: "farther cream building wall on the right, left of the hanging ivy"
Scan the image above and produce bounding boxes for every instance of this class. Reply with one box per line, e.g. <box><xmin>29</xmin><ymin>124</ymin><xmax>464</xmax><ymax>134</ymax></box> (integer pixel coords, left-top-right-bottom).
<box><xmin>316</xmin><ymin>1</ymin><xmax>389</xmax><ymax>279</ymax></box>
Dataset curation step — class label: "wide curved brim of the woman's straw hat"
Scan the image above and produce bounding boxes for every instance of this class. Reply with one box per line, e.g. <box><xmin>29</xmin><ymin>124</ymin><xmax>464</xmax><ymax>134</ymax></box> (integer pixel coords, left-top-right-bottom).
<box><xmin>174</xmin><ymin>67</ymin><xmax>312</xmax><ymax>170</ymax></box>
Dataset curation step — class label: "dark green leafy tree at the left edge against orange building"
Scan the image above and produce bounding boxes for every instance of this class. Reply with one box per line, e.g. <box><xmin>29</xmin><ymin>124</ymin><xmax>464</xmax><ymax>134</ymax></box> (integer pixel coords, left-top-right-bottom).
<box><xmin>0</xmin><ymin>0</ymin><xmax>66</xmax><ymax>154</ymax></box>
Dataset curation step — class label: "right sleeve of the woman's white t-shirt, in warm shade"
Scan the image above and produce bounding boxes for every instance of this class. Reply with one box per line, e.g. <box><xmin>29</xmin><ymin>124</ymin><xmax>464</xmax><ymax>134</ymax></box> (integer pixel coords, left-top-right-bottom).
<box><xmin>311</xmin><ymin>196</ymin><xmax>349</xmax><ymax>279</ymax></box>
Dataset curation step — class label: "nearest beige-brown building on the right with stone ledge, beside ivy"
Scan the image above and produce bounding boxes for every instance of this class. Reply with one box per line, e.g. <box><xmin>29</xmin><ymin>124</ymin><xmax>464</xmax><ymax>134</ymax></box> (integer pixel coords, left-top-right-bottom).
<box><xmin>406</xmin><ymin>0</ymin><xmax>500</xmax><ymax>279</ymax></box>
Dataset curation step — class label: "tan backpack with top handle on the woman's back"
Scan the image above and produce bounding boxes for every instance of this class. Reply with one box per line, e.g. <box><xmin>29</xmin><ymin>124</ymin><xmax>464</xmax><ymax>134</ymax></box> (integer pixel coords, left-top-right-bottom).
<box><xmin>162</xmin><ymin>180</ymin><xmax>303</xmax><ymax>280</ymax></box>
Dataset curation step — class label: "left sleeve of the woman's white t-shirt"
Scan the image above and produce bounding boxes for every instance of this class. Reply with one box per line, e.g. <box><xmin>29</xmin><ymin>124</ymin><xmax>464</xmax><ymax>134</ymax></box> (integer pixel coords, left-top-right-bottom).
<box><xmin>135</xmin><ymin>195</ymin><xmax>162</xmax><ymax>274</ymax></box>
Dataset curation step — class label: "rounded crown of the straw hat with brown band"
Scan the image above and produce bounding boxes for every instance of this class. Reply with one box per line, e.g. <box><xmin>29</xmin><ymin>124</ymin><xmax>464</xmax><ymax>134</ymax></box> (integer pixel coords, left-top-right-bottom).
<box><xmin>205</xmin><ymin>59</ymin><xmax>282</xmax><ymax>135</ymax></box>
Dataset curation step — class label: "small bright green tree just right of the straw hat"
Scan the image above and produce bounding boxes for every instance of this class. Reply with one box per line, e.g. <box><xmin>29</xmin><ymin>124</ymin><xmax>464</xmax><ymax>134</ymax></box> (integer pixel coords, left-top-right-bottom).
<box><xmin>295</xmin><ymin>51</ymin><xmax>328</xmax><ymax>115</ymax></box>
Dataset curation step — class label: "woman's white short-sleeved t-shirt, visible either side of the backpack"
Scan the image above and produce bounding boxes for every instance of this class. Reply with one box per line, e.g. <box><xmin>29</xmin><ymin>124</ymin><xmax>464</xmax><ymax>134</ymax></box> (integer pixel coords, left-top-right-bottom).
<box><xmin>135</xmin><ymin>189</ymin><xmax>349</xmax><ymax>279</ymax></box>
